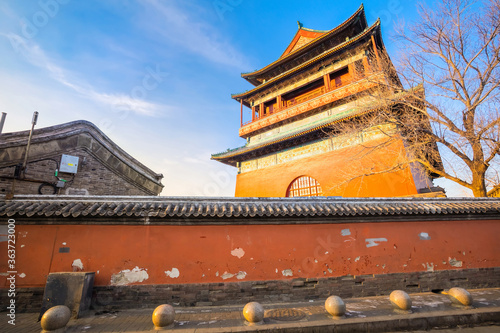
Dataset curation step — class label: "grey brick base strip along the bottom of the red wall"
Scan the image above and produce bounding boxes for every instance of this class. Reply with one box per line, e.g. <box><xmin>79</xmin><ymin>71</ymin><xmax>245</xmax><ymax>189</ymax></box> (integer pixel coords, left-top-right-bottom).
<box><xmin>0</xmin><ymin>267</ymin><xmax>500</xmax><ymax>312</ymax></box>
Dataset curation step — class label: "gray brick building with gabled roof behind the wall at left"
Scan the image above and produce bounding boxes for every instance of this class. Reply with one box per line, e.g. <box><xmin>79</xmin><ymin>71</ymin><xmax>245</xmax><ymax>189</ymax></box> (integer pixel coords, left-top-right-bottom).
<box><xmin>0</xmin><ymin>120</ymin><xmax>163</xmax><ymax>195</ymax></box>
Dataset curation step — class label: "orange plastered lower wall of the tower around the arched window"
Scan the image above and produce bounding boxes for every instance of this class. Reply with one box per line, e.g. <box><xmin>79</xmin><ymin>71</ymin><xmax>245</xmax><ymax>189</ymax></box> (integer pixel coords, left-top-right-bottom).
<box><xmin>235</xmin><ymin>140</ymin><xmax>417</xmax><ymax>197</ymax></box>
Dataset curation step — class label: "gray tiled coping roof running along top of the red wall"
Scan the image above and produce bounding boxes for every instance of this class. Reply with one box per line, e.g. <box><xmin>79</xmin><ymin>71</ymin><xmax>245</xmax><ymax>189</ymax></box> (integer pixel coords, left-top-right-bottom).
<box><xmin>0</xmin><ymin>195</ymin><xmax>500</xmax><ymax>223</ymax></box>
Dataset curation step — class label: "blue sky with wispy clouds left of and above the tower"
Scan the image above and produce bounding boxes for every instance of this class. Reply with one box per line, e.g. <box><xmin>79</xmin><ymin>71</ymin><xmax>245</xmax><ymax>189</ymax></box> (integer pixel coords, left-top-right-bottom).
<box><xmin>0</xmin><ymin>0</ymin><xmax>468</xmax><ymax>196</ymax></box>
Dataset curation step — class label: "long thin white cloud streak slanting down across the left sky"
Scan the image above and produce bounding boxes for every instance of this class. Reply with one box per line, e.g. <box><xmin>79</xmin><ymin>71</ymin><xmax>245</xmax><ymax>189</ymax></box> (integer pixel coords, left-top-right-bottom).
<box><xmin>2</xmin><ymin>33</ymin><xmax>169</xmax><ymax>116</ymax></box>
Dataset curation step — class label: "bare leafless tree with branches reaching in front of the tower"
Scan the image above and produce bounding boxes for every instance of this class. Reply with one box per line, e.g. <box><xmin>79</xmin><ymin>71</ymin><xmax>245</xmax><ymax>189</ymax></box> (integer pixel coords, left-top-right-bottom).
<box><xmin>332</xmin><ymin>0</ymin><xmax>500</xmax><ymax>197</ymax></box>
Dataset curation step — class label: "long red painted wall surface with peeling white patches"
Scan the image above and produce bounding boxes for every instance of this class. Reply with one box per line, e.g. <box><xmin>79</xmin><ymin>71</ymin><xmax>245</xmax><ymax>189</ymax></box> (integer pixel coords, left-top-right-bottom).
<box><xmin>0</xmin><ymin>220</ymin><xmax>500</xmax><ymax>288</ymax></box>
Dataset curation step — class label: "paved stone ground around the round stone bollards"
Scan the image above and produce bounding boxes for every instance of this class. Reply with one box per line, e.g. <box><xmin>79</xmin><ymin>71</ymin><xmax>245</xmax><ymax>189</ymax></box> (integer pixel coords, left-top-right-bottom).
<box><xmin>0</xmin><ymin>288</ymin><xmax>500</xmax><ymax>333</ymax></box>
